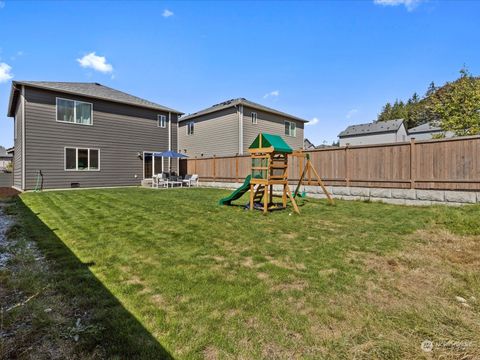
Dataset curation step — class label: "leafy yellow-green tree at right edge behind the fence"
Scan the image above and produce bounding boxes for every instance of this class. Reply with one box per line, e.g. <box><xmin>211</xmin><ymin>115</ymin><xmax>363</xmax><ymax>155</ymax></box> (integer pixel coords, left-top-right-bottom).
<box><xmin>428</xmin><ymin>68</ymin><xmax>480</xmax><ymax>136</ymax></box>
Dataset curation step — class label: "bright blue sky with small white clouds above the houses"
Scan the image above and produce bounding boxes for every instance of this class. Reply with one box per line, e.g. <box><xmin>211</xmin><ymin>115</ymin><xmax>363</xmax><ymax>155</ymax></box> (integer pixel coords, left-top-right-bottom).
<box><xmin>0</xmin><ymin>0</ymin><xmax>480</xmax><ymax>146</ymax></box>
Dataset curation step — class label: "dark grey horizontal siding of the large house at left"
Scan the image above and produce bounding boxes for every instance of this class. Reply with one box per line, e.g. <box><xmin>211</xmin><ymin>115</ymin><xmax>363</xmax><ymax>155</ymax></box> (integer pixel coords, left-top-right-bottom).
<box><xmin>22</xmin><ymin>87</ymin><xmax>177</xmax><ymax>190</ymax></box>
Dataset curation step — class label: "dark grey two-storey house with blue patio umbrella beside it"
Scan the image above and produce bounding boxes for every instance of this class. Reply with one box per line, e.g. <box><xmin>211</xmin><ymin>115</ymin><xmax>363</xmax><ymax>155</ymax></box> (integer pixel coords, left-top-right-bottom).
<box><xmin>8</xmin><ymin>81</ymin><xmax>182</xmax><ymax>190</ymax></box>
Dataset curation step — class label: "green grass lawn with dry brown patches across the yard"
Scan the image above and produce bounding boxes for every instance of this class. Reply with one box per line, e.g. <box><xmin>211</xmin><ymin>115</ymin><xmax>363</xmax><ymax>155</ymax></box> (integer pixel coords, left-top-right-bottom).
<box><xmin>10</xmin><ymin>189</ymin><xmax>480</xmax><ymax>359</ymax></box>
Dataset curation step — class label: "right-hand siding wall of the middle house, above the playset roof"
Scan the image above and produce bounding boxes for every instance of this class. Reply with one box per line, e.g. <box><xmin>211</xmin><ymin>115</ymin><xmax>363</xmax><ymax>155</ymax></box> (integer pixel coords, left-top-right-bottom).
<box><xmin>243</xmin><ymin>106</ymin><xmax>304</xmax><ymax>153</ymax></box>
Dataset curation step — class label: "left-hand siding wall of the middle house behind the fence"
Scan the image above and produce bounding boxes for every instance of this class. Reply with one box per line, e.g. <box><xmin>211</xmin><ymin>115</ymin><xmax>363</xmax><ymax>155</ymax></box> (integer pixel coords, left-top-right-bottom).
<box><xmin>178</xmin><ymin>106</ymin><xmax>239</xmax><ymax>157</ymax></box>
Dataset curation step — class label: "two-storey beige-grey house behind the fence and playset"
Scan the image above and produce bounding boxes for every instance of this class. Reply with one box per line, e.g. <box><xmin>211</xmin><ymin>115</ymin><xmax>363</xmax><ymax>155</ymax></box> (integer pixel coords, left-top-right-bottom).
<box><xmin>178</xmin><ymin>98</ymin><xmax>308</xmax><ymax>157</ymax></box>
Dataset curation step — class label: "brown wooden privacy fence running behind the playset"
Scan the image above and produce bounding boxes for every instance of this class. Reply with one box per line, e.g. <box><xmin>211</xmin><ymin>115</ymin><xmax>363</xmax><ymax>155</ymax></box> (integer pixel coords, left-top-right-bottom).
<box><xmin>181</xmin><ymin>136</ymin><xmax>480</xmax><ymax>191</ymax></box>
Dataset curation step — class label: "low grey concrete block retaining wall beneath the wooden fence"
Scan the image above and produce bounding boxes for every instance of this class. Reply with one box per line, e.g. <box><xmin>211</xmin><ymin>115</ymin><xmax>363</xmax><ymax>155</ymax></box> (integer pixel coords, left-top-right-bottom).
<box><xmin>200</xmin><ymin>182</ymin><xmax>480</xmax><ymax>206</ymax></box>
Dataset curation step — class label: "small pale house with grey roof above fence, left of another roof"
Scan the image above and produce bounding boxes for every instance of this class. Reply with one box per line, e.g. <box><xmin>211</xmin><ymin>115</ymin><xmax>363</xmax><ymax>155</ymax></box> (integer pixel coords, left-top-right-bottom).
<box><xmin>338</xmin><ymin>119</ymin><xmax>408</xmax><ymax>146</ymax></box>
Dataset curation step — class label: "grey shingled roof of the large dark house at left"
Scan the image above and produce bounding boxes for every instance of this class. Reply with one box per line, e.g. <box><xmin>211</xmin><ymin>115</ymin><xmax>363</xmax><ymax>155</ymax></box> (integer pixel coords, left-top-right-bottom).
<box><xmin>8</xmin><ymin>81</ymin><xmax>183</xmax><ymax>116</ymax></box>
